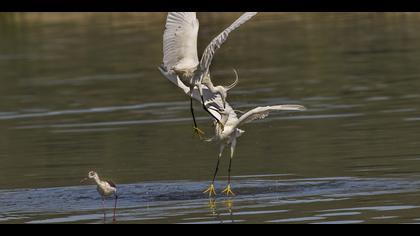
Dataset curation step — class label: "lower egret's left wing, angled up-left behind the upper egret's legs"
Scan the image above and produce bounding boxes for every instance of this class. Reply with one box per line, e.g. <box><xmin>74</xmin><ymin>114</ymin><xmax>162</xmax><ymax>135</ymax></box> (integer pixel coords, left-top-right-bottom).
<box><xmin>158</xmin><ymin>66</ymin><xmax>225</xmax><ymax>120</ymax></box>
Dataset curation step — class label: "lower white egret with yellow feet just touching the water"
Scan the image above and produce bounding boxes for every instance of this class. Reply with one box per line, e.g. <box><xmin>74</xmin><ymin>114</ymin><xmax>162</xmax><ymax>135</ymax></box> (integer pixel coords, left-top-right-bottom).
<box><xmin>159</xmin><ymin>66</ymin><xmax>306</xmax><ymax>197</ymax></box>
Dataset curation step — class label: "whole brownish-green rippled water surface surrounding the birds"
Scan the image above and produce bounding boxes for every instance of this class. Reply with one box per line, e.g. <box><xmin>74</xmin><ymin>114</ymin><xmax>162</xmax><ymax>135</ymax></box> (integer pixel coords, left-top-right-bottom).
<box><xmin>0</xmin><ymin>13</ymin><xmax>420</xmax><ymax>223</ymax></box>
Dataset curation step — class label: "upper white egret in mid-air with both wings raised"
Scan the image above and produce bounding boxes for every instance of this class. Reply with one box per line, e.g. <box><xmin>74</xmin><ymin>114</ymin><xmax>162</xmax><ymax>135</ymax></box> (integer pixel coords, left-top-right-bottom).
<box><xmin>163</xmin><ymin>12</ymin><xmax>257</xmax><ymax>137</ymax></box>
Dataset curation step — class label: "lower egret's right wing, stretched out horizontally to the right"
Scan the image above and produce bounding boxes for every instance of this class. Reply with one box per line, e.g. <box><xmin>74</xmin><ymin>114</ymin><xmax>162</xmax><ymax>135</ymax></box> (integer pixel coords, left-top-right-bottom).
<box><xmin>237</xmin><ymin>105</ymin><xmax>306</xmax><ymax>127</ymax></box>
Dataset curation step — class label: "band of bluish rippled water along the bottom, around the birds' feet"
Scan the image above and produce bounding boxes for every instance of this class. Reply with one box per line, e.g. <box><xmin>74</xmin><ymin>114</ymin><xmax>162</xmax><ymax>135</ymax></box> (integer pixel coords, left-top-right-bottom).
<box><xmin>0</xmin><ymin>174</ymin><xmax>420</xmax><ymax>224</ymax></box>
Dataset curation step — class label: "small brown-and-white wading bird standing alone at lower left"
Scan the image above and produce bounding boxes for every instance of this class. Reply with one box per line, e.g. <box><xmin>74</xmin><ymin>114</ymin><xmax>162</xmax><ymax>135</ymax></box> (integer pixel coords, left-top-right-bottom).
<box><xmin>80</xmin><ymin>171</ymin><xmax>118</xmax><ymax>221</ymax></box>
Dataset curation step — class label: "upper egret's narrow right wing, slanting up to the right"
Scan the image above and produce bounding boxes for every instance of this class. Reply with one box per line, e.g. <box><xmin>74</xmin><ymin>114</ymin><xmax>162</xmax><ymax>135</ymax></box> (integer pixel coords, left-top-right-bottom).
<box><xmin>200</xmin><ymin>12</ymin><xmax>257</xmax><ymax>71</ymax></box>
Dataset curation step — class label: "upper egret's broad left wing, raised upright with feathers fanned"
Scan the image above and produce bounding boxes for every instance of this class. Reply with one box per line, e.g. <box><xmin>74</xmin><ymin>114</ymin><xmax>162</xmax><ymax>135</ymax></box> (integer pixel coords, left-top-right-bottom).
<box><xmin>163</xmin><ymin>12</ymin><xmax>199</xmax><ymax>70</ymax></box>
